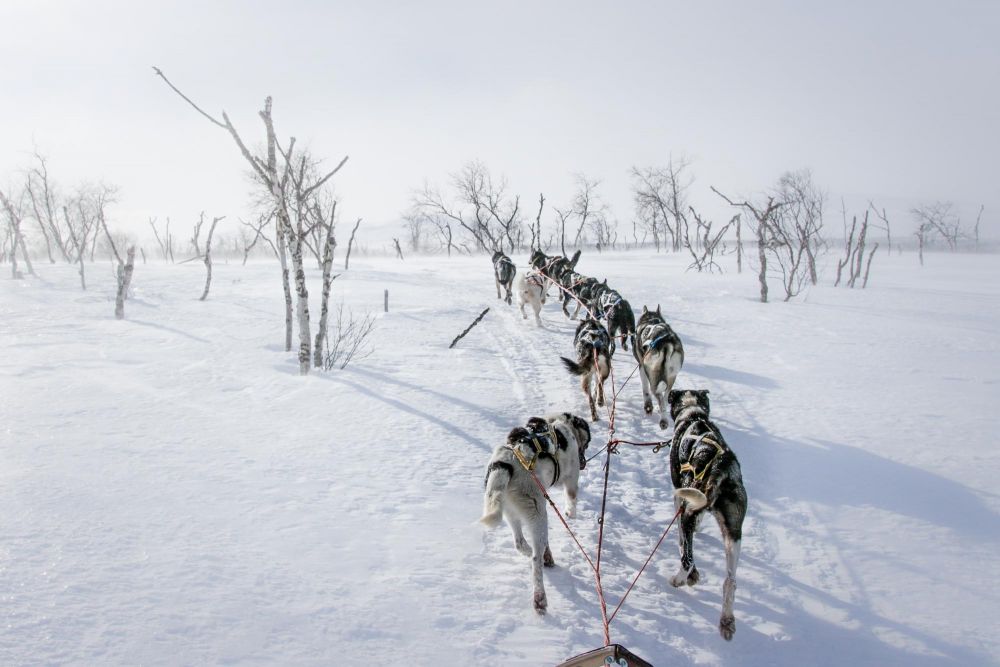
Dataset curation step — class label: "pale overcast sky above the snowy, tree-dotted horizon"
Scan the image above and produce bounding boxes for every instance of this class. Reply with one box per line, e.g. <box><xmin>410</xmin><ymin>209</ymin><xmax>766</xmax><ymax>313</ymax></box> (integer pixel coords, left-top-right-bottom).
<box><xmin>0</xmin><ymin>0</ymin><xmax>1000</xmax><ymax>245</ymax></box>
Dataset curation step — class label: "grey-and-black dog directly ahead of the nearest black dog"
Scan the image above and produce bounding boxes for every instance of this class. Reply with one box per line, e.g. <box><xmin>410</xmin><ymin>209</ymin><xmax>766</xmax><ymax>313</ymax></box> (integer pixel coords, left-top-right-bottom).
<box><xmin>632</xmin><ymin>306</ymin><xmax>684</xmax><ymax>428</ymax></box>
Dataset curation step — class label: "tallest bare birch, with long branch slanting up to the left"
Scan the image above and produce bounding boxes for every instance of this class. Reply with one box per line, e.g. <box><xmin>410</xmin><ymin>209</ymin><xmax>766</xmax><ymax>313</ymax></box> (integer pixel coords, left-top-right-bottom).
<box><xmin>153</xmin><ymin>67</ymin><xmax>347</xmax><ymax>375</ymax></box>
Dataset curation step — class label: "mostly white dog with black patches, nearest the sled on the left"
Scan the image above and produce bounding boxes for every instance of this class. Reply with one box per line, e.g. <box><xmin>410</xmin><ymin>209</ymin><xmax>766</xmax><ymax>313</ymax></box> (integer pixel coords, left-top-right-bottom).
<box><xmin>479</xmin><ymin>412</ymin><xmax>590</xmax><ymax>614</ymax></box>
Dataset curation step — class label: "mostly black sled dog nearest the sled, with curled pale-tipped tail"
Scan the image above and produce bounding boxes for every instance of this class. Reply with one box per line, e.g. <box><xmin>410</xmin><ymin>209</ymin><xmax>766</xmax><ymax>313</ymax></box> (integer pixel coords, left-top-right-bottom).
<box><xmin>669</xmin><ymin>390</ymin><xmax>747</xmax><ymax>640</ymax></box>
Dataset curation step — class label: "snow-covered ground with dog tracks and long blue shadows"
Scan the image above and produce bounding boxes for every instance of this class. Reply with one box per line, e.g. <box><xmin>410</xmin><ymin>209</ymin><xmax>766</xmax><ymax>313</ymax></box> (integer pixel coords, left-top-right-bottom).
<box><xmin>0</xmin><ymin>252</ymin><xmax>1000</xmax><ymax>666</ymax></box>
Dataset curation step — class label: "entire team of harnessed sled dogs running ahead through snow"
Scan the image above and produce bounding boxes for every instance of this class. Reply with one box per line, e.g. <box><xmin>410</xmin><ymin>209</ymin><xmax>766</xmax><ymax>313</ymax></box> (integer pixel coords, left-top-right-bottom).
<box><xmin>480</xmin><ymin>250</ymin><xmax>747</xmax><ymax>640</ymax></box>
